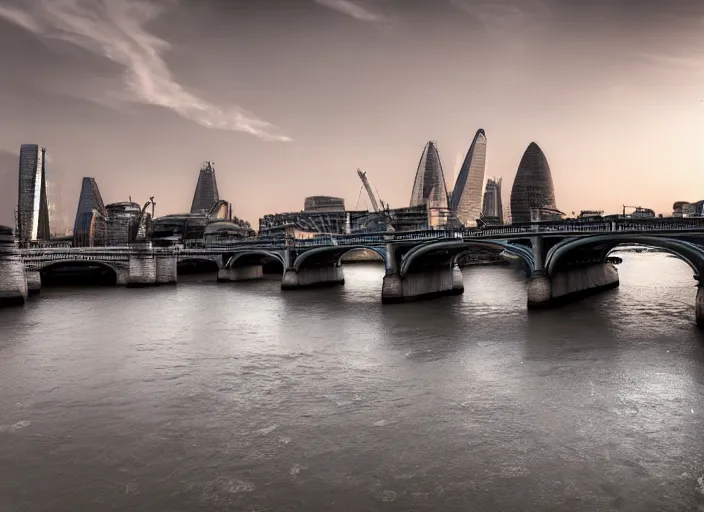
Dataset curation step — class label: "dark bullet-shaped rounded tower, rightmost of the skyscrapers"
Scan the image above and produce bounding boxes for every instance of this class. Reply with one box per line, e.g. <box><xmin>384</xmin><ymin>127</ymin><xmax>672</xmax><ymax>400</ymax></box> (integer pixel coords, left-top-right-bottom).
<box><xmin>511</xmin><ymin>142</ymin><xmax>557</xmax><ymax>223</ymax></box>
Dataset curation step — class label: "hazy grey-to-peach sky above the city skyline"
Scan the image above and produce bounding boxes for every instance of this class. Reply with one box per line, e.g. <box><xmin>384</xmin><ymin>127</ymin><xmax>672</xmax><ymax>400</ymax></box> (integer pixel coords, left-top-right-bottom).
<box><xmin>0</xmin><ymin>0</ymin><xmax>704</xmax><ymax>227</ymax></box>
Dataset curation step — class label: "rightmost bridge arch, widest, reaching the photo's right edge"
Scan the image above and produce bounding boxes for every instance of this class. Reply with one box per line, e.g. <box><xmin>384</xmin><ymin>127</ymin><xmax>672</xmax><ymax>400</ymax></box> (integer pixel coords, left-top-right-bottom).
<box><xmin>545</xmin><ymin>233</ymin><xmax>704</xmax><ymax>276</ymax></box>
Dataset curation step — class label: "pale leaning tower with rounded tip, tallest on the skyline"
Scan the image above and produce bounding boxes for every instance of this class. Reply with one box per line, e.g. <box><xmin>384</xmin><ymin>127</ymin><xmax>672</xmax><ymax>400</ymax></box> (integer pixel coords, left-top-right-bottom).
<box><xmin>450</xmin><ymin>129</ymin><xmax>486</xmax><ymax>226</ymax></box>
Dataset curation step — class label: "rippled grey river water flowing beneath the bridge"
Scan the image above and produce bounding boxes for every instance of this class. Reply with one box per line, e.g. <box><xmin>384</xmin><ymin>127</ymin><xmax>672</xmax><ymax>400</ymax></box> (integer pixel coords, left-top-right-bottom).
<box><xmin>0</xmin><ymin>253</ymin><xmax>704</xmax><ymax>512</ymax></box>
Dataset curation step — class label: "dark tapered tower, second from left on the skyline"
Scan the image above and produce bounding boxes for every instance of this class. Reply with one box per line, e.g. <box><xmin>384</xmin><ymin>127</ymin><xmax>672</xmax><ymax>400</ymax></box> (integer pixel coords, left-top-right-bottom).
<box><xmin>73</xmin><ymin>178</ymin><xmax>107</xmax><ymax>247</ymax></box>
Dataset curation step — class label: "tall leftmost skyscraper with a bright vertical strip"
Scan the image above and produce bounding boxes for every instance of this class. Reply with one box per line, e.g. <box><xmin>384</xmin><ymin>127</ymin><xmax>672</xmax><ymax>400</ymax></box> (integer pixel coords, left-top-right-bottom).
<box><xmin>17</xmin><ymin>144</ymin><xmax>51</xmax><ymax>242</ymax></box>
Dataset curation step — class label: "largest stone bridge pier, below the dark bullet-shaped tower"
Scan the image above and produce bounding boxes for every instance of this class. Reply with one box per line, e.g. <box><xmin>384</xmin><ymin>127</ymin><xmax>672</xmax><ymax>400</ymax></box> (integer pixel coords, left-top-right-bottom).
<box><xmin>528</xmin><ymin>263</ymin><xmax>620</xmax><ymax>309</ymax></box>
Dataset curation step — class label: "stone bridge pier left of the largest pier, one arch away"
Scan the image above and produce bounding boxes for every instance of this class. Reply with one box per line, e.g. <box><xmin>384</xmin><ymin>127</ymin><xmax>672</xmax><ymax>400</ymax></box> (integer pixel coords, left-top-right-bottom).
<box><xmin>381</xmin><ymin>265</ymin><xmax>464</xmax><ymax>304</ymax></box>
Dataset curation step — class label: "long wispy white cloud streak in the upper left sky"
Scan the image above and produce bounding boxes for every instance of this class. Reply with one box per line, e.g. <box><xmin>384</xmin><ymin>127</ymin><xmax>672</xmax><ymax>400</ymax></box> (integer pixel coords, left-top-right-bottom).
<box><xmin>0</xmin><ymin>0</ymin><xmax>291</xmax><ymax>142</ymax></box>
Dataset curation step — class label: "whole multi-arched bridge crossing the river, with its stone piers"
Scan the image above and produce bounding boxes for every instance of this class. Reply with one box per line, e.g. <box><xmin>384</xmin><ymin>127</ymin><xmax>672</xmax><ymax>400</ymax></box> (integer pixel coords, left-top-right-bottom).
<box><xmin>0</xmin><ymin>218</ymin><xmax>704</xmax><ymax>323</ymax></box>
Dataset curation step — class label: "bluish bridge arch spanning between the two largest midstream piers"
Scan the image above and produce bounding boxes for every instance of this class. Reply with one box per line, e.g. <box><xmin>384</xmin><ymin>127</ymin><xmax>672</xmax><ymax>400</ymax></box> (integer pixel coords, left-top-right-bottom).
<box><xmin>400</xmin><ymin>240</ymin><xmax>535</xmax><ymax>277</ymax></box>
